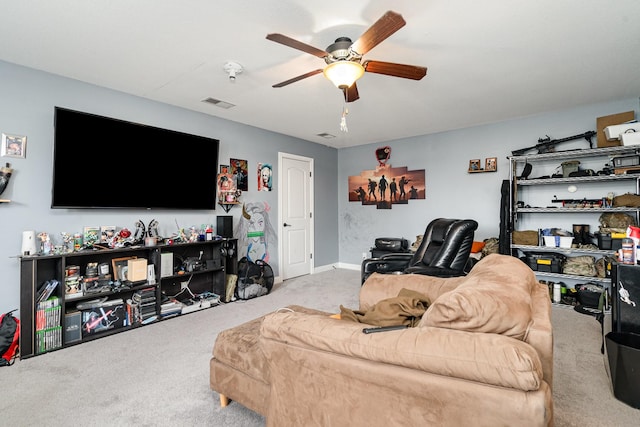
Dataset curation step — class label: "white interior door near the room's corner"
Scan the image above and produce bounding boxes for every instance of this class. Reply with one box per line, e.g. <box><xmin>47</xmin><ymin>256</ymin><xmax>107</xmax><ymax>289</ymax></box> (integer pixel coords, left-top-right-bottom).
<box><xmin>278</xmin><ymin>153</ymin><xmax>313</xmax><ymax>280</ymax></box>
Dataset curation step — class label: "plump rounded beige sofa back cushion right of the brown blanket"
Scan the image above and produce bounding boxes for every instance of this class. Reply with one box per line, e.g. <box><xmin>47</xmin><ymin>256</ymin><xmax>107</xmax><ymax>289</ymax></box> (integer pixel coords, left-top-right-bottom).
<box><xmin>418</xmin><ymin>254</ymin><xmax>537</xmax><ymax>340</ymax></box>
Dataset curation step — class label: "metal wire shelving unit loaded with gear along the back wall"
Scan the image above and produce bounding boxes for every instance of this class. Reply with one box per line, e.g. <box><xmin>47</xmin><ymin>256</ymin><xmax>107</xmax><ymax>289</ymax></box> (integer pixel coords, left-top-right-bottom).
<box><xmin>507</xmin><ymin>145</ymin><xmax>640</xmax><ymax>304</ymax></box>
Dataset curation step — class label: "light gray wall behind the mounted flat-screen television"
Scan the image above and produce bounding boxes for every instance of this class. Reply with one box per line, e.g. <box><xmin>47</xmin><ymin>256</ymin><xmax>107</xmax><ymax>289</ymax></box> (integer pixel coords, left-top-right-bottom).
<box><xmin>0</xmin><ymin>61</ymin><xmax>338</xmax><ymax>312</ymax></box>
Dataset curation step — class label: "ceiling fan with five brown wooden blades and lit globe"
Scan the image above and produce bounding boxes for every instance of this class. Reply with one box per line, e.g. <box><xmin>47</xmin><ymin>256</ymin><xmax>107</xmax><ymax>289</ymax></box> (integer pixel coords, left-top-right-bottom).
<box><xmin>267</xmin><ymin>11</ymin><xmax>427</xmax><ymax>102</ymax></box>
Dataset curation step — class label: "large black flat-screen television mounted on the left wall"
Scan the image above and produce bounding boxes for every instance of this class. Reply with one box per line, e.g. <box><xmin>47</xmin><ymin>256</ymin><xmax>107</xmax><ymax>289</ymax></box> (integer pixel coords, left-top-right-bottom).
<box><xmin>51</xmin><ymin>107</ymin><xmax>219</xmax><ymax>209</ymax></box>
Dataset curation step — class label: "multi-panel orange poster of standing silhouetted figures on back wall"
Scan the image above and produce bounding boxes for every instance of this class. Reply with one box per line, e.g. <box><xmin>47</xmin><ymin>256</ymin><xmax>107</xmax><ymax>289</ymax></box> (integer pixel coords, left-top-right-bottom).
<box><xmin>349</xmin><ymin>166</ymin><xmax>427</xmax><ymax>209</ymax></box>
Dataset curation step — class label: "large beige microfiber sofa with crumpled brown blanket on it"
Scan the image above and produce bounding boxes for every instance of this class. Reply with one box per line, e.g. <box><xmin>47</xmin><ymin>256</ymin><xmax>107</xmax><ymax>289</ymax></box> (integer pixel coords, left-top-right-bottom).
<box><xmin>211</xmin><ymin>254</ymin><xmax>553</xmax><ymax>427</ymax></box>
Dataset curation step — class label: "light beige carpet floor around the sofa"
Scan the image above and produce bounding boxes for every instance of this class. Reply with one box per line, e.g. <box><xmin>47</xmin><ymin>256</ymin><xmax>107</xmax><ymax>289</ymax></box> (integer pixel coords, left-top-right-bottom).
<box><xmin>0</xmin><ymin>269</ymin><xmax>640</xmax><ymax>427</ymax></box>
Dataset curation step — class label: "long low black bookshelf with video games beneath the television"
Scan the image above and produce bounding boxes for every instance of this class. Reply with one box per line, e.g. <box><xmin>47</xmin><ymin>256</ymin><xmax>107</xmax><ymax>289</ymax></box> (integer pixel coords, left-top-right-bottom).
<box><xmin>20</xmin><ymin>239</ymin><xmax>237</xmax><ymax>358</ymax></box>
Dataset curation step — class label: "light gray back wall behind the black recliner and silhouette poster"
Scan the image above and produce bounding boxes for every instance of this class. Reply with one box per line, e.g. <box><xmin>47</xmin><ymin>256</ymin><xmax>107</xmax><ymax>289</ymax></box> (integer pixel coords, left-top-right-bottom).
<box><xmin>338</xmin><ymin>97</ymin><xmax>638</xmax><ymax>266</ymax></box>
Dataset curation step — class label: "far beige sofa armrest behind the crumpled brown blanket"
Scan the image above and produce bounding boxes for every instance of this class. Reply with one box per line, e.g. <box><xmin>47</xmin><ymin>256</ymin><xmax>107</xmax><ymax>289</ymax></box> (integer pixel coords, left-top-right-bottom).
<box><xmin>360</xmin><ymin>273</ymin><xmax>465</xmax><ymax>310</ymax></box>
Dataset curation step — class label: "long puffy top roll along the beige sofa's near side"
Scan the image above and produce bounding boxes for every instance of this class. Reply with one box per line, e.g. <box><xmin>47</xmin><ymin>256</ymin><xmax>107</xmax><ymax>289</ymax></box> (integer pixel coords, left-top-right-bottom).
<box><xmin>260</xmin><ymin>312</ymin><xmax>543</xmax><ymax>391</ymax></box>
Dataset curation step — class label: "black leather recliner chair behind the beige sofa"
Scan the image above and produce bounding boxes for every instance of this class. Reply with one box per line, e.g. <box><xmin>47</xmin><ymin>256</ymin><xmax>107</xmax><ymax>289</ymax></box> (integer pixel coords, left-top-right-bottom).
<box><xmin>361</xmin><ymin>218</ymin><xmax>478</xmax><ymax>283</ymax></box>
